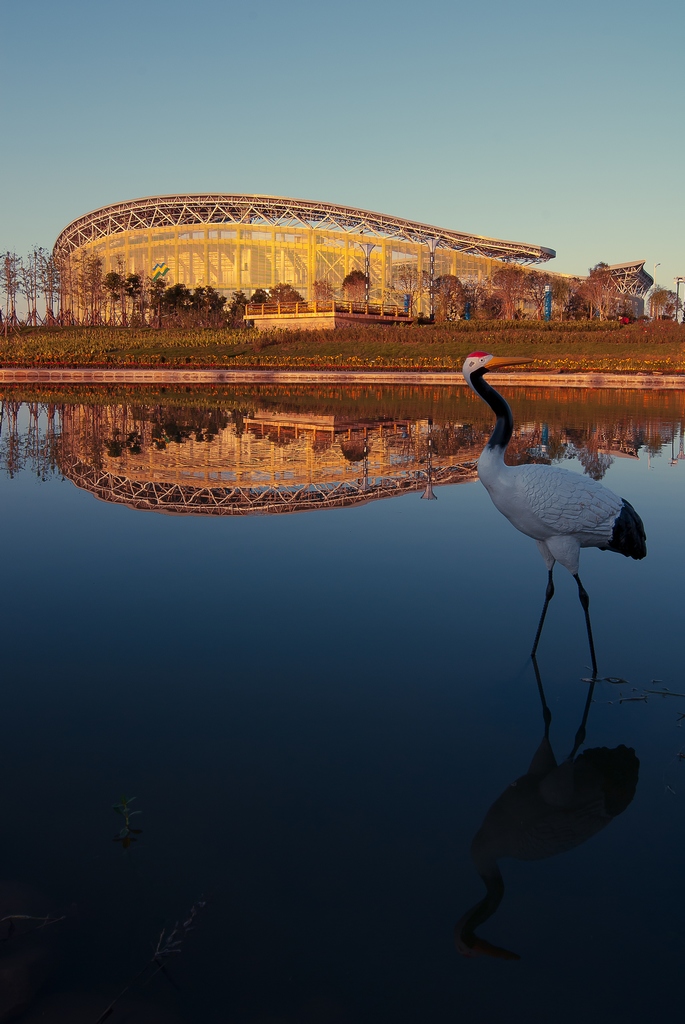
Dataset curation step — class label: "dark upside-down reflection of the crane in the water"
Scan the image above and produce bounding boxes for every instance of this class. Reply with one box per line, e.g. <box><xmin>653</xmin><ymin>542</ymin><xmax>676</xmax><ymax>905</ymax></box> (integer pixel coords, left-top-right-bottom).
<box><xmin>455</xmin><ymin>655</ymin><xmax>640</xmax><ymax>959</ymax></box>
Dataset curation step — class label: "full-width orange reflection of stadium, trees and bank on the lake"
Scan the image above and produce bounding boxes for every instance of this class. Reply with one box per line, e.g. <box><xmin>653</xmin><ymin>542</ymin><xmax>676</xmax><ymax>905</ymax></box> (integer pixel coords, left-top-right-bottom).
<box><xmin>2</xmin><ymin>388</ymin><xmax>685</xmax><ymax>515</ymax></box>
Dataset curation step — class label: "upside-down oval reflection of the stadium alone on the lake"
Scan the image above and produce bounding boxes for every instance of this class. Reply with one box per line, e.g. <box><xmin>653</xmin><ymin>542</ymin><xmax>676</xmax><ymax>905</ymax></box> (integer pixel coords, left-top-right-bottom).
<box><xmin>54</xmin><ymin>407</ymin><xmax>477</xmax><ymax>515</ymax></box>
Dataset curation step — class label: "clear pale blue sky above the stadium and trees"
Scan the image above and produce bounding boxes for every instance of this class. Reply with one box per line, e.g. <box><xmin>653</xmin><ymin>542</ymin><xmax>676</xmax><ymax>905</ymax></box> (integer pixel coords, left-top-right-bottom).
<box><xmin>0</xmin><ymin>0</ymin><xmax>685</xmax><ymax>287</ymax></box>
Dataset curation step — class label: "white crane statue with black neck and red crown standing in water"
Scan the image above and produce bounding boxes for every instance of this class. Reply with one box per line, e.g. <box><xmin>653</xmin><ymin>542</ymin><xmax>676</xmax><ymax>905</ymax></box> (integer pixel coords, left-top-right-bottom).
<box><xmin>462</xmin><ymin>352</ymin><xmax>647</xmax><ymax>676</ymax></box>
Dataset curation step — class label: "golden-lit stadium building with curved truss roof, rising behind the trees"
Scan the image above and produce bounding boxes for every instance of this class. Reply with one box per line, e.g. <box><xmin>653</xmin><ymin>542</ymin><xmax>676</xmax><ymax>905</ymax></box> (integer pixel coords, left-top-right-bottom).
<box><xmin>54</xmin><ymin>194</ymin><xmax>555</xmax><ymax>311</ymax></box>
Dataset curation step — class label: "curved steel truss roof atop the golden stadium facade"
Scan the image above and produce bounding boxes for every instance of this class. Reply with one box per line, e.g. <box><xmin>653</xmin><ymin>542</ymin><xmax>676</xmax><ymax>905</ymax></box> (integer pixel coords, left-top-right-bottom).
<box><xmin>54</xmin><ymin>193</ymin><xmax>556</xmax><ymax>263</ymax></box>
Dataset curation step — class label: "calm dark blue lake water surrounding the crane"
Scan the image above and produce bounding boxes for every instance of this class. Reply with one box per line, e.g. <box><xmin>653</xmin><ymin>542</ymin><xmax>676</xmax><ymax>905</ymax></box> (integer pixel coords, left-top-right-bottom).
<box><xmin>0</xmin><ymin>385</ymin><xmax>685</xmax><ymax>1024</ymax></box>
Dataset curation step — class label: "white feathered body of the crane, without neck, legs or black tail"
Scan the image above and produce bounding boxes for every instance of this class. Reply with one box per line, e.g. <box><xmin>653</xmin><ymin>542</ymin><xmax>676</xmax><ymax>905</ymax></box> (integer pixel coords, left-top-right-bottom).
<box><xmin>478</xmin><ymin>446</ymin><xmax>624</xmax><ymax>574</ymax></box>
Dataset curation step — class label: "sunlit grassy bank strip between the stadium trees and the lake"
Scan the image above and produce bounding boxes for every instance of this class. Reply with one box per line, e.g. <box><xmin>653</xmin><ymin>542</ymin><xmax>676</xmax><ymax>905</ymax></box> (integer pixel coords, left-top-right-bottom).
<box><xmin>0</xmin><ymin>321</ymin><xmax>685</xmax><ymax>373</ymax></box>
